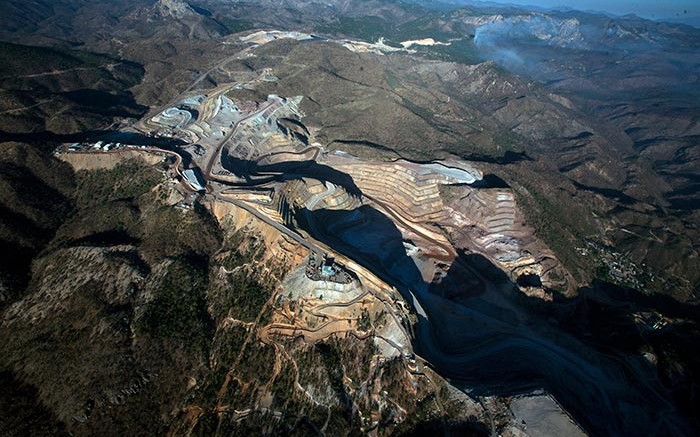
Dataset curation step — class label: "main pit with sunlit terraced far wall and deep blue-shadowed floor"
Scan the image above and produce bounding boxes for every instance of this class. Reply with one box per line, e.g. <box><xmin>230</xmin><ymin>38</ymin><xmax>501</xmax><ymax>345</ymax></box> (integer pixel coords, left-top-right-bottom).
<box><xmin>209</xmin><ymin>85</ymin><xmax>686</xmax><ymax>435</ymax></box>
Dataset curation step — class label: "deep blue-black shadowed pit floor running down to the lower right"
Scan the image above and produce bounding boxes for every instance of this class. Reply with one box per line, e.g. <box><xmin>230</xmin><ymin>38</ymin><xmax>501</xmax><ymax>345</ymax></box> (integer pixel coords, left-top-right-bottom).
<box><xmin>297</xmin><ymin>206</ymin><xmax>687</xmax><ymax>435</ymax></box>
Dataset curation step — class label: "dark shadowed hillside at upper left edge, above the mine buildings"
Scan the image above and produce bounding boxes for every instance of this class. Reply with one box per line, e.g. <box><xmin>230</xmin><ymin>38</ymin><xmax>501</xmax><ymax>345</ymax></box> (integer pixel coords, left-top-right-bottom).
<box><xmin>0</xmin><ymin>43</ymin><xmax>144</xmax><ymax>136</ymax></box>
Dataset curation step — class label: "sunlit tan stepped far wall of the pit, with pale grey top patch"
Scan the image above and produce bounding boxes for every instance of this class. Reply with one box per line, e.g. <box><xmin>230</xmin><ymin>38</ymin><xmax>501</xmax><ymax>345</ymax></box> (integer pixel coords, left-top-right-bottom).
<box><xmin>320</xmin><ymin>157</ymin><xmax>575</xmax><ymax>299</ymax></box>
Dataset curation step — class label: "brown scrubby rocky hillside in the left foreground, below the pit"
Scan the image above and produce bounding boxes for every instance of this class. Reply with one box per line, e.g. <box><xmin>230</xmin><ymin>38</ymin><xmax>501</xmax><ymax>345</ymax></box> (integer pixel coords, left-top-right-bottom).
<box><xmin>0</xmin><ymin>161</ymin><xmax>507</xmax><ymax>435</ymax></box>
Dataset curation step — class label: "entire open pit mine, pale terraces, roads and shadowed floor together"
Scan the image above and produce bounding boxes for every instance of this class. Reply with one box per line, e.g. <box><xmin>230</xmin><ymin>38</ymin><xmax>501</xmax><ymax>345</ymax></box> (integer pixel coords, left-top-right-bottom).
<box><xmin>47</xmin><ymin>32</ymin><xmax>688</xmax><ymax>435</ymax></box>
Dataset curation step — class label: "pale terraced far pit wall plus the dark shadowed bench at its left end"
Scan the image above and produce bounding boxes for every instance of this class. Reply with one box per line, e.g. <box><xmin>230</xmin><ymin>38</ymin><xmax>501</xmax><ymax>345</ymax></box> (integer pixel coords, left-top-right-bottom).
<box><xmin>250</xmin><ymin>147</ymin><xmax>575</xmax><ymax>299</ymax></box>
